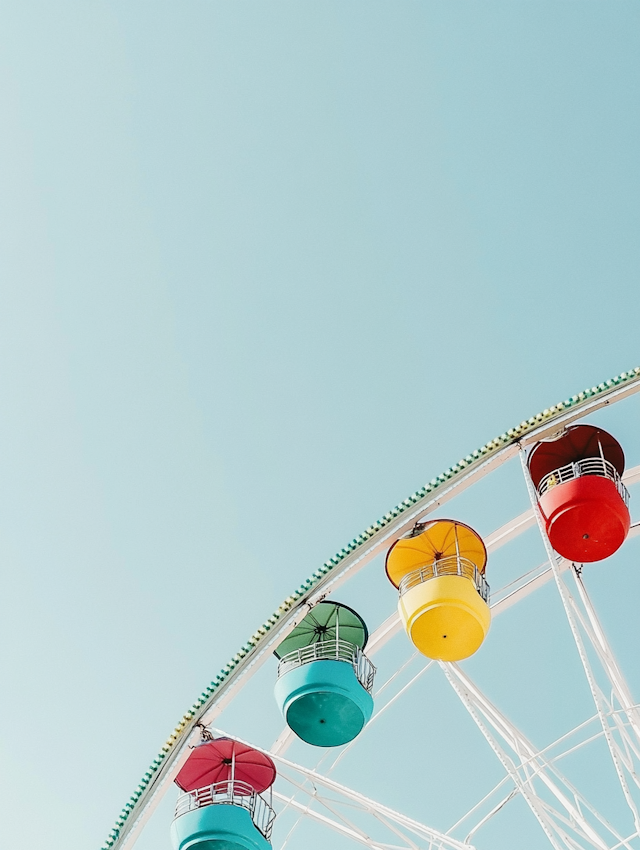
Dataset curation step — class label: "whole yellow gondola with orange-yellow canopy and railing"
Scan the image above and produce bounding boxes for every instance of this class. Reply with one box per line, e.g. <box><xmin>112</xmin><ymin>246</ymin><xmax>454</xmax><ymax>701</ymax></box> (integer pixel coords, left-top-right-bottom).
<box><xmin>386</xmin><ymin>519</ymin><xmax>491</xmax><ymax>661</ymax></box>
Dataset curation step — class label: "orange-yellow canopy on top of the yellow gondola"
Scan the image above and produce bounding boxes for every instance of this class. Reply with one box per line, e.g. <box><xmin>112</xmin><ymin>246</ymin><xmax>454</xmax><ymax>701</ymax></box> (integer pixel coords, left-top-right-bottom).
<box><xmin>386</xmin><ymin>519</ymin><xmax>487</xmax><ymax>587</ymax></box>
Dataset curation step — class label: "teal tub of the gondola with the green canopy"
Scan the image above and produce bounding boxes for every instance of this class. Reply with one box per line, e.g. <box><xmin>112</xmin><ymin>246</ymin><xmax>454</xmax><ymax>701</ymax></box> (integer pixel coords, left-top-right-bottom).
<box><xmin>274</xmin><ymin>659</ymin><xmax>373</xmax><ymax>747</ymax></box>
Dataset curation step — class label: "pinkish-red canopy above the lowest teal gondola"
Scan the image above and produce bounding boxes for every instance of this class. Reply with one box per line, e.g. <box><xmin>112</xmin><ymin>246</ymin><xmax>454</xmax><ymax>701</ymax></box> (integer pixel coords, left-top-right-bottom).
<box><xmin>176</xmin><ymin>738</ymin><xmax>276</xmax><ymax>794</ymax></box>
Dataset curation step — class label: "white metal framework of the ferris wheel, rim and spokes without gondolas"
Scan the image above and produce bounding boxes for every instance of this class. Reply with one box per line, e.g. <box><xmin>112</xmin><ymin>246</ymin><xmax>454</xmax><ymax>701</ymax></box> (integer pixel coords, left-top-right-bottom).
<box><xmin>105</xmin><ymin>370</ymin><xmax>640</xmax><ymax>850</ymax></box>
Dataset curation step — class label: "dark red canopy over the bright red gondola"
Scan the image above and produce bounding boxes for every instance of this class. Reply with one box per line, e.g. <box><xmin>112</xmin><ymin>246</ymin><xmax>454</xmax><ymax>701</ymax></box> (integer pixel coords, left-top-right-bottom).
<box><xmin>528</xmin><ymin>425</ymin><xmax>624</xmax><ymax>487</ymax></box>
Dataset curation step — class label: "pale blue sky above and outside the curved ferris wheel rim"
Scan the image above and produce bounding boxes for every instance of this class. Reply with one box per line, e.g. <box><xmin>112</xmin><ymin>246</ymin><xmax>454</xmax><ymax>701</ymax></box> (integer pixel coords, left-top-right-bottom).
<box><xmin>0</xmin><ymin>0</ymin><xmax>640</xmax><ymax>850</ymax></box>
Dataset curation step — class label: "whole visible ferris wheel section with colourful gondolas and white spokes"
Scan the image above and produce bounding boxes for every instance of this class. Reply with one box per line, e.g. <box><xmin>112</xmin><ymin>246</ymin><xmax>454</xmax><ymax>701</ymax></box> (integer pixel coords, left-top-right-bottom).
<box><xmin>103</xmin><ymin>368</ymin><xmax>640</xmax><ymax>850</ymax></box>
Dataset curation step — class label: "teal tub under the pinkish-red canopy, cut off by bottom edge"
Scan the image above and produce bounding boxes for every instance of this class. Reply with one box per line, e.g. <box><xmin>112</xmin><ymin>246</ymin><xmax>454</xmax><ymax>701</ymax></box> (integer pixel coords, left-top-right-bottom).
<box><xmin>171</xmin><ymin>803</ymin><xmax>271</xmax><ymax>850</ymax></box>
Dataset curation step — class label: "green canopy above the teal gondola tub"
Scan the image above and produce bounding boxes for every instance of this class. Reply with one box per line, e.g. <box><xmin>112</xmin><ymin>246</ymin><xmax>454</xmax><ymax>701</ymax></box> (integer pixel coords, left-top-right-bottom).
<box><xmin>274</xmin><ymin>602</ymin><xmax>369</xmax><ymax>658</ymax></box>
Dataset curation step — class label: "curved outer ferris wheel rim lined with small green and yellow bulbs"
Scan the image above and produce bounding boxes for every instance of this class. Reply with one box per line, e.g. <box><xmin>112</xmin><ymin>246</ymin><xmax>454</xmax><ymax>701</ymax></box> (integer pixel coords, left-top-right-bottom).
<box><xmin>101</xmin><ymin>367</ymin><xmax>640</xmax><ymax>850</ymax></box>
